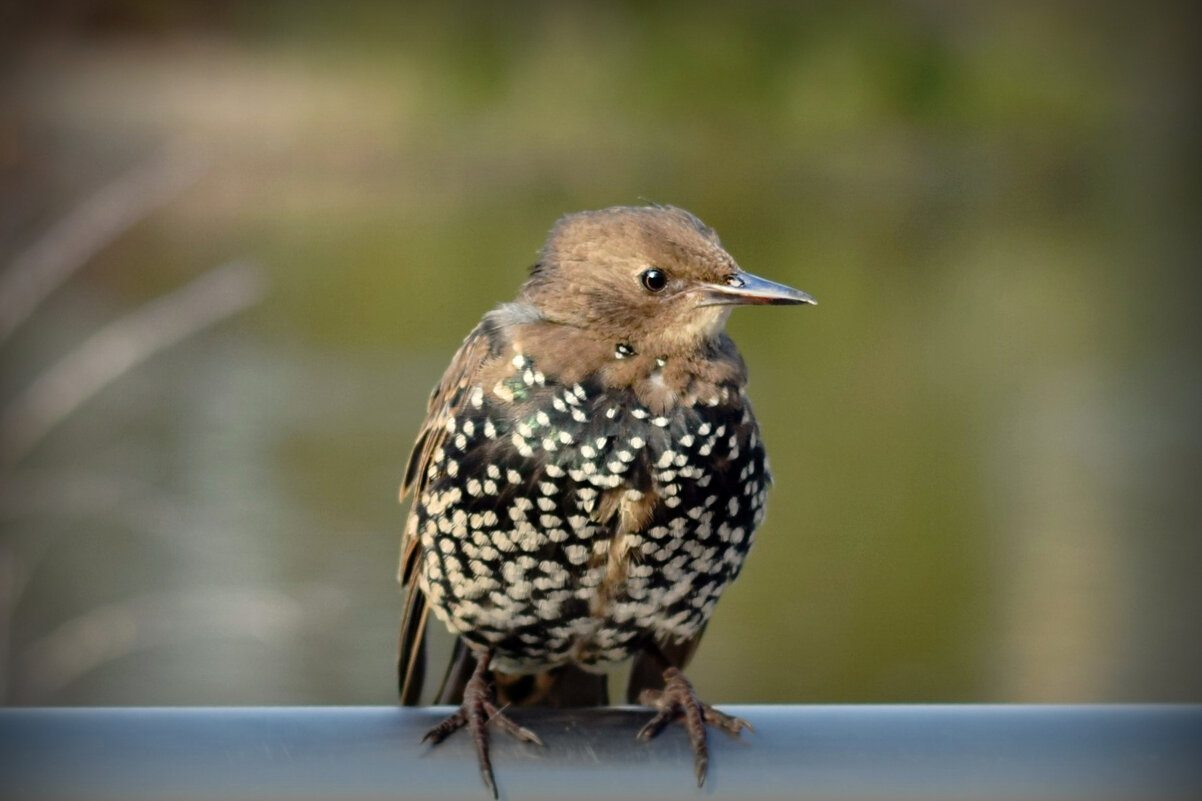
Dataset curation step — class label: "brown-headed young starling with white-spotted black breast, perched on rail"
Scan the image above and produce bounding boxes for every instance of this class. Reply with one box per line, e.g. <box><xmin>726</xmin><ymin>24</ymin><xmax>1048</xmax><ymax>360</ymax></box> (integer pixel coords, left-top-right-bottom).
<box><xmin>399</xmin><ymin>200</ymin><xmax>814</xmax><ymax>796</ymax></box>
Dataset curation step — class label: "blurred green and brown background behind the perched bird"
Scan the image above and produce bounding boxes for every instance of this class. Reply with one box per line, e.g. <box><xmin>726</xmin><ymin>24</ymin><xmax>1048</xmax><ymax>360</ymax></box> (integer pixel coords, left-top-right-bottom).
<box><xmin>0</xmin><ymin>0</ymin><xmax>1202</xmax><ymax>705</ymax></box>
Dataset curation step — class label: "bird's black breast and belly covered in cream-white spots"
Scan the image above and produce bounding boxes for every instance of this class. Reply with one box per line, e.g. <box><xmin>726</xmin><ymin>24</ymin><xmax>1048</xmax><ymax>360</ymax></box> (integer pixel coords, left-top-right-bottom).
<box><xmin>417</xmin><ymin>356</ymin><xmax>770</xmax><ymax>672</ymax></box>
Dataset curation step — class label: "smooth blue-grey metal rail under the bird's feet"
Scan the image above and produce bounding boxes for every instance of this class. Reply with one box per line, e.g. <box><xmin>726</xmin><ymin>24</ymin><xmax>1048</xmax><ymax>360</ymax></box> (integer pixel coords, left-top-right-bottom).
<box><xmin>0</xmin><ymin>706</ymin><xmax>1202</xmax><ymax>801</ymax></box>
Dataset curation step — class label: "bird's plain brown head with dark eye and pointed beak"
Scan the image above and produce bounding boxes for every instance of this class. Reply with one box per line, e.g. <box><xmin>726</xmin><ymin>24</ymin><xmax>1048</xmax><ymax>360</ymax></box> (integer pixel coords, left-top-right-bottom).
<box><xmin>522</xmin><ymin>206</ymin><xmax>814</xmax><ymax>356</ymax></box>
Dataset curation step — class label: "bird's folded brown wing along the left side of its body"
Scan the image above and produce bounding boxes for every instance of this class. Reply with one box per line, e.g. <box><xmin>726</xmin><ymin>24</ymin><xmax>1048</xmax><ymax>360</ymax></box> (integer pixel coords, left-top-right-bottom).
<box><xmin>397</xmin><ymin>326</ymin><xmax>492</xmax><ymax>706</ymax></box>
